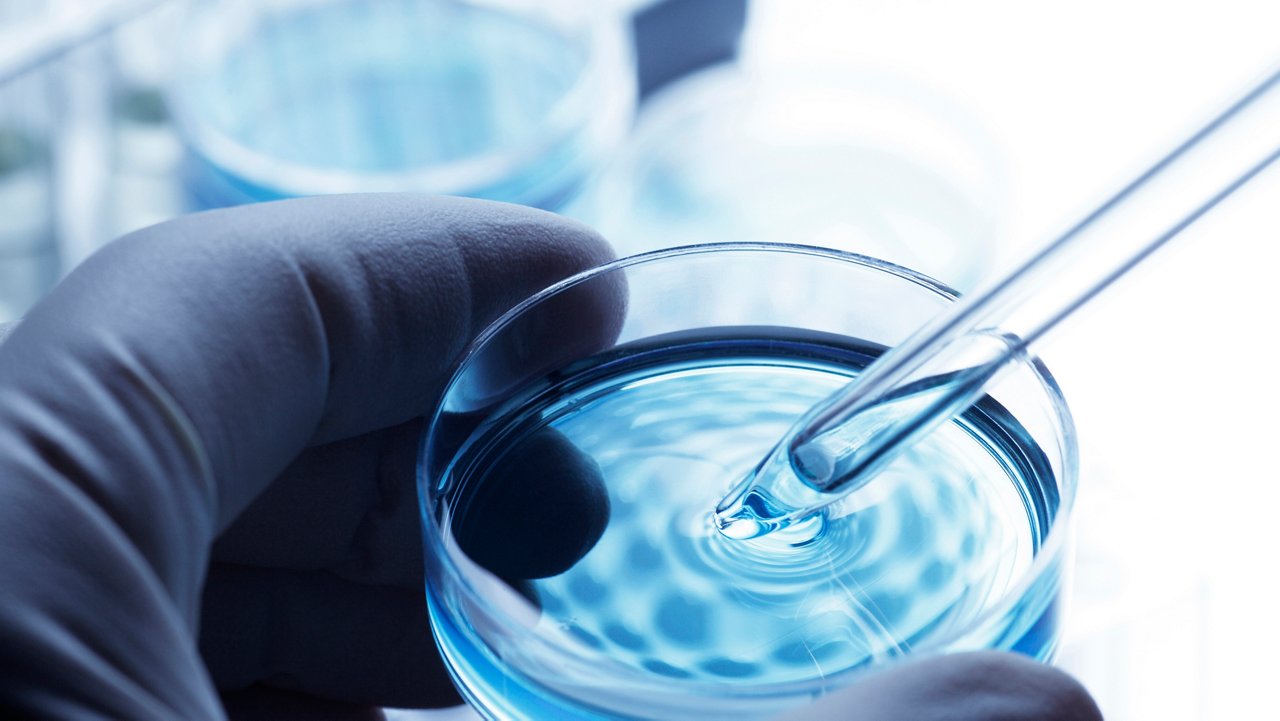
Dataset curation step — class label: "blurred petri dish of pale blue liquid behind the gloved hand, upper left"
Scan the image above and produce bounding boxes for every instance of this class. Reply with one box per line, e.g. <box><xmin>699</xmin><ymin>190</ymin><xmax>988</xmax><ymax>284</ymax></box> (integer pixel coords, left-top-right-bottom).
<box><xmin>172</xmin><ymin>0</ymin><xmax>635</xmax><ymax>209</ymax></box>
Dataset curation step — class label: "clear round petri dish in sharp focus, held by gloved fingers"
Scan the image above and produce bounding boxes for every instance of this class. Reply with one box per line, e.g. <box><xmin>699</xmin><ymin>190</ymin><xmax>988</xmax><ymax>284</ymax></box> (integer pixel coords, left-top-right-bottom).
<box><xmin>419</xmin><ymin>243</ymin><xmax>1076</xmax><ymax>718</ymax></box>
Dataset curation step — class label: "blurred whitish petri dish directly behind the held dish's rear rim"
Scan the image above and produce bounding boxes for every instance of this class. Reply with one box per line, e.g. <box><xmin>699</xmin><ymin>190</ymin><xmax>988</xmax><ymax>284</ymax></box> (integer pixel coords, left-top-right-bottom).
<box><xmin>570</xmin><ymin>65</ymin><xmax>1005</xmax><ymax>291</ymax></box>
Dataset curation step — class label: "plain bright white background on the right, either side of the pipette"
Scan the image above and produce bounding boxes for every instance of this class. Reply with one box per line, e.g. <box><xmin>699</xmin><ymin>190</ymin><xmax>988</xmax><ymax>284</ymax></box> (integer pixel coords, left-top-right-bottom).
<box><xmin>750</xmin><ymin>0</ymin><xmax>1280</xmax><ymax>721</ymax></box>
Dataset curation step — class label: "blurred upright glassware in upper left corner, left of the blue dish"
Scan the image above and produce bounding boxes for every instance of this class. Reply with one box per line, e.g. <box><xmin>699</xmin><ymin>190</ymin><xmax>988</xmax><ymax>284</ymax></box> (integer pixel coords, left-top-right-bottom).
<box><xmin>0</xmin><ymin>0</ymin><xmax>183</xmax><ymax>319</ymax></box>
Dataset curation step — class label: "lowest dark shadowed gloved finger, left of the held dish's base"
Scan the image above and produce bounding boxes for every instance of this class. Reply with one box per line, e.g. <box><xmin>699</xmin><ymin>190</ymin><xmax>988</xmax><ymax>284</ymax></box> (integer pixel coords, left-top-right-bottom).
<box><xmin>200</xmin><ymin>565</ymin><xmax>460</xmax><ymax>708</ymax></box>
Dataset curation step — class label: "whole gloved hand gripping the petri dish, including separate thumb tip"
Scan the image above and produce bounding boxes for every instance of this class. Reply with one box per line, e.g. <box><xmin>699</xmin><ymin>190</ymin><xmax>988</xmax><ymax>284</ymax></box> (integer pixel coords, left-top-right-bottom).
<box><xmin>0</xmin><ymin>196</ymin><xmax>1098</xmax><ymax>721</ymax></box>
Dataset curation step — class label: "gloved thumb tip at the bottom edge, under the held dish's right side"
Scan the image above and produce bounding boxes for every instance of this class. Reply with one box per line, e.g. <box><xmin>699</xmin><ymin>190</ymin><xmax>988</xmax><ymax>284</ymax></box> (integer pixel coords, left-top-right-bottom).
<box><xmin>780</xmin><ymin>651</ymin><xmax>1102</xmax><ymax>721</ymax></box>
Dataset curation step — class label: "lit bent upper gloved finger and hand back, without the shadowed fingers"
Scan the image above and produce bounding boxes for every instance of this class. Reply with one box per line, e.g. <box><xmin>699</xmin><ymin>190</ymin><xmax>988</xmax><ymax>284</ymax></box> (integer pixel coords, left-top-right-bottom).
<box><xmin>0</xmin><ymin>196</ymin><xmax>621</xmax><ymax>717</ymax></box>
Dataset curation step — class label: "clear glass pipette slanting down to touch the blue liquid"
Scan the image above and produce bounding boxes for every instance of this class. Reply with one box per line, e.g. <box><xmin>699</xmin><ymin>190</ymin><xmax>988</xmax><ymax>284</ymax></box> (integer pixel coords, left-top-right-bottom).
<box><xmin>716</xmin><ymin>70</ymin><xmax>1280</xmax><ymax>542</ymax></box>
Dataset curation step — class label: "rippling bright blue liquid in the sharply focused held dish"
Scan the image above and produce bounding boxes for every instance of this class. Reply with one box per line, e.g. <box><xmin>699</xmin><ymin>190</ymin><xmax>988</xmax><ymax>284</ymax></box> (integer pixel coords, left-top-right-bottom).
<box><xmin>429</xmin><ymin>332</ymin><xmax>1059</xmax><ymax>717</ymax></box>
